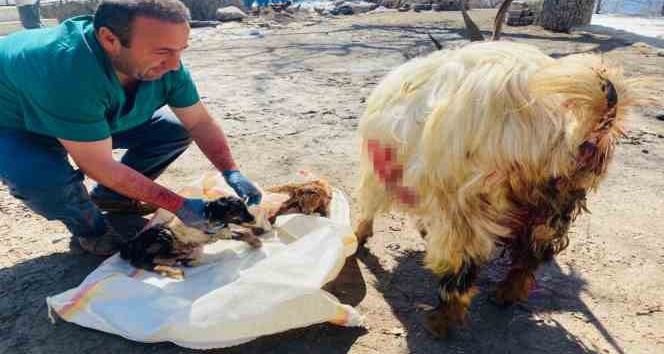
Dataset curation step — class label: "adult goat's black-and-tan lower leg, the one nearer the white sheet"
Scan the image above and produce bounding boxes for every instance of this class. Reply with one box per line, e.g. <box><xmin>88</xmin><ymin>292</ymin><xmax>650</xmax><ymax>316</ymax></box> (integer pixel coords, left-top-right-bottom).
<box><xmin>424</xmin><ymin>261</ymin><xmax>479</xmax><ymax>338</ymax></box>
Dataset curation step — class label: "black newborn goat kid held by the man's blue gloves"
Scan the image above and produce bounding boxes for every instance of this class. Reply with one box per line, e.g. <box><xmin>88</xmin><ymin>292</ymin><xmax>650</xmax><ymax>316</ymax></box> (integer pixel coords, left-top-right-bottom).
<box><xmin>120</xmin><ymin>196</ymin><xmax>261</xmax><ymax>279</ymax></box>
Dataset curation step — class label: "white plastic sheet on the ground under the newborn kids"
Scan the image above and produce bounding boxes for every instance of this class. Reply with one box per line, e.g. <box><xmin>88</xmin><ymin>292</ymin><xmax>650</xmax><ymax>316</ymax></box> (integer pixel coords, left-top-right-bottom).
<box><xmin>46</xmin><ymin>175</ymin><xmax>362</xmax><ymax>349</ymax></box>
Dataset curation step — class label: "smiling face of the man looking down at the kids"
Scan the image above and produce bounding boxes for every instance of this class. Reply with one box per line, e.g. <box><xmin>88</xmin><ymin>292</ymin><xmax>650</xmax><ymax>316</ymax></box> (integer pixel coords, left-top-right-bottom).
<box><xmin>111</xmin><ymin>17</ymin><xmax>189</xmax><ymax>81</ymax></box>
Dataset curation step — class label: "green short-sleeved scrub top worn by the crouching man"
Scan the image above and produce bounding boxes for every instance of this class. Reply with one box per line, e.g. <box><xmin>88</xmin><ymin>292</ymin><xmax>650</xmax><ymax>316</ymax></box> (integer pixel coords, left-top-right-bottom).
<box><xmin>0</xmin><ymin>16</ymin><xmax>199</xmax><ymax>141</ymax></box>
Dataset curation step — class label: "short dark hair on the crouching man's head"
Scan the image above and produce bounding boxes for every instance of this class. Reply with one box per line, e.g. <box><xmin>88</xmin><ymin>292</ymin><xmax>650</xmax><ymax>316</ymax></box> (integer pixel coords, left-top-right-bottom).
<box><xmin>94</xmin><ymin>0</ymin><xmax>189</xmax><ymax>47</ymax></box>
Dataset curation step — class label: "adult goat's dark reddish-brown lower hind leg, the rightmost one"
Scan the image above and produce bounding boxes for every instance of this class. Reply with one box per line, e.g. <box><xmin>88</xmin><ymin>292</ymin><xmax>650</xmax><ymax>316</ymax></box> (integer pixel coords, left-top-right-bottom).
<box><xmin>493</xmin><ymin>246</ymin><xmax>554</xmax><ymax>306</ymax></box>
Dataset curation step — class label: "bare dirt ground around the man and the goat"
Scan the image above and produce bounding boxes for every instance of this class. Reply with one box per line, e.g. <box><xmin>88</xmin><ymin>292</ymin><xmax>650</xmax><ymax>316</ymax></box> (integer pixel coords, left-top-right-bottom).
<box><xmin>0</xmin><ymin>11</ymin><xmax>664</xmax><ymax>354</ymax></box>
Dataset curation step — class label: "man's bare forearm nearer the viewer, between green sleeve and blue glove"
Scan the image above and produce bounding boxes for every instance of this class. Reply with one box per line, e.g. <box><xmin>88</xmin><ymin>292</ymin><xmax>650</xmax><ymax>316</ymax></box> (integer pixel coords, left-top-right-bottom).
<box><xmin>58</xmin><ymin>138</ymin><xmax>184</xmax><ymax>213</ymax></box>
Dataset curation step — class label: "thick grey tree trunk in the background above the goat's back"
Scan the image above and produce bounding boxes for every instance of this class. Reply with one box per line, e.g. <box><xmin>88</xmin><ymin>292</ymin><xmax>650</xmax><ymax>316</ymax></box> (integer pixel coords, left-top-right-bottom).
<box><xmin>540</xmin><ymin>0</ymin><xmax>594</xmax><ymax>32</ymax></box>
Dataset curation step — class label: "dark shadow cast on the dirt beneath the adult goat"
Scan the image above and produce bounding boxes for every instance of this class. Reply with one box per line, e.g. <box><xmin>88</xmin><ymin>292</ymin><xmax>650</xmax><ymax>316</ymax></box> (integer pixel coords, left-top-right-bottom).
<box><xmin>359</xmin><ymin>245</ymin><xmax>624</xmax><ymax>354</ymax></box>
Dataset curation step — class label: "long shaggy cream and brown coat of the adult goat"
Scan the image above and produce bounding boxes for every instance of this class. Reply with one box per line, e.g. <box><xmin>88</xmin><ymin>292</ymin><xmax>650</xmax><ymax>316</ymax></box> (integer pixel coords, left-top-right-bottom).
<box><xmin>357</xmin><ymin>42</ymin><xmax>645</xmax><ymax>334</ymax></box>
